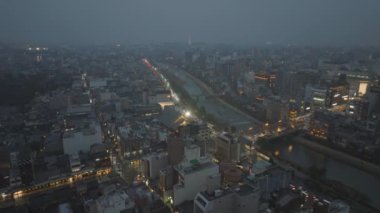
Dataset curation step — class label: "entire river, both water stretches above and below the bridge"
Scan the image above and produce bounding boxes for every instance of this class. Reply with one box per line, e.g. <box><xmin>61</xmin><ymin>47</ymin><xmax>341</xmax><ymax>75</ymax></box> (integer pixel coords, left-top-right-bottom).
<box><xmin>157</xmin><ymin>61</ymin><xmax>380</xmax><ymax>209</ymax></box>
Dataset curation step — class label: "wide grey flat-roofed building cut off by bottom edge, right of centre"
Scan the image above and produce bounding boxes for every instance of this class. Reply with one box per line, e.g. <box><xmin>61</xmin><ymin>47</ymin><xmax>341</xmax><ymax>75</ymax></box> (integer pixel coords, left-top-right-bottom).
<box><xmin>194</xmin><ymin>184</ymin><xmax>260</xmax><ymax>213</ymax></box>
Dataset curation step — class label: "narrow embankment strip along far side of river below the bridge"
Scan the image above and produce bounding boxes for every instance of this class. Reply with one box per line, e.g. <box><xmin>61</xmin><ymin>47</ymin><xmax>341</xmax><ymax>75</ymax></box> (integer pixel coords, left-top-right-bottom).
<box><xmin>294</xmin><ymin>135</ymin><xmax>380</xmax><ymax>177</ymax></box>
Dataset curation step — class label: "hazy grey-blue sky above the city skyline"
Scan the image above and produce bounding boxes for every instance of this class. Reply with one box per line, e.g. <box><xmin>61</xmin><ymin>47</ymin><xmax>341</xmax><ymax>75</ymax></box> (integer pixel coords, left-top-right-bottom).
<box><xmin>0</xmin><ymin>0</ymin><xmax>380</xmax><ymax>46</ymax></box>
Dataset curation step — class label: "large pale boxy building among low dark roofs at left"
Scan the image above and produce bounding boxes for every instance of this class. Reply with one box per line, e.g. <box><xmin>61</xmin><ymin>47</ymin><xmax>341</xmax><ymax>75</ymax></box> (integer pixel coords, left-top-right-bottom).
<box><xmin>63</xmin><ymin>121</ymin><xmax>102</xmax><ymax>155</ymax></box>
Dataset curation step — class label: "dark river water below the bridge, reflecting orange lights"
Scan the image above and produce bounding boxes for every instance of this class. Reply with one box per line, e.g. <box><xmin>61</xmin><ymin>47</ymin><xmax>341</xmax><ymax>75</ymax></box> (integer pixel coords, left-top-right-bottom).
<box><xmin>266</xmin><ymin>141</ymin><xmax>380</xmax><ymax>209</ymax></box>
